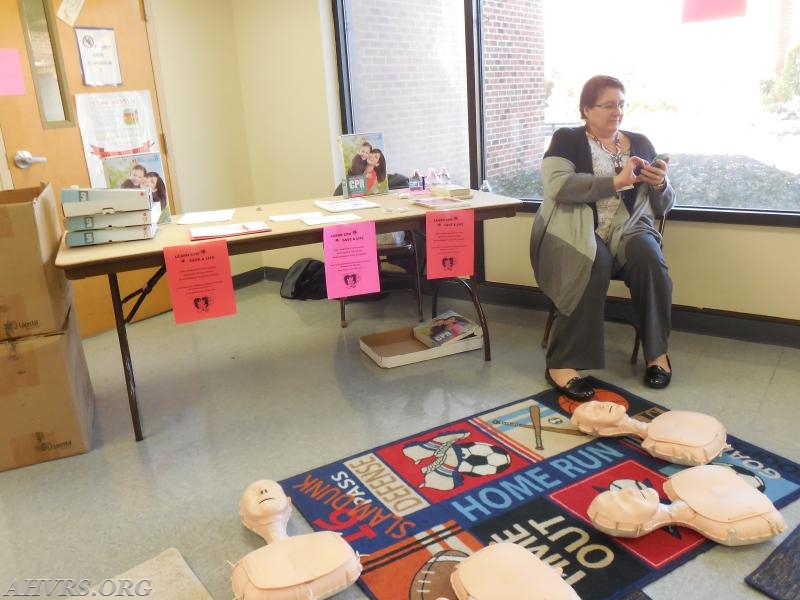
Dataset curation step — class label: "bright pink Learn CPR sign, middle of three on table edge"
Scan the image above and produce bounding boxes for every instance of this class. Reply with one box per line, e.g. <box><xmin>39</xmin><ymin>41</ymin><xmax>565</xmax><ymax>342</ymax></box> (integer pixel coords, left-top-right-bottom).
<box><xmin>322</xmin><ymin>221</ymin><xmax>381</xmax><ymax>299</ymax></box>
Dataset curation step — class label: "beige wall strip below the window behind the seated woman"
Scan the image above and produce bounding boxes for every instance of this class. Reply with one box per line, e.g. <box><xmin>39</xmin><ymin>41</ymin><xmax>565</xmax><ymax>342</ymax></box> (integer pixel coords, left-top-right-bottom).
<box><xmin>486</xmin><ymin>214</ymin><xmax>800</xmax><ymax>320</ymax></box>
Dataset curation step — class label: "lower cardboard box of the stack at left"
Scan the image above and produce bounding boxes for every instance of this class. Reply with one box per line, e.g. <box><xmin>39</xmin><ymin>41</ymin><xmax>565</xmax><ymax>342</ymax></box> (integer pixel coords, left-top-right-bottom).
<box><xmin>0</xmin><ymin>314</ymin><xmax>95</xmax><ymax>471</ymax></box>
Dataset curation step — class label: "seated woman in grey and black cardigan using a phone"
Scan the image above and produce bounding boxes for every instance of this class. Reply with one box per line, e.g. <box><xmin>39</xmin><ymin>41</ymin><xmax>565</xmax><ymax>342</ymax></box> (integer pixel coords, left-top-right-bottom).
<box><xmin>531</xmin><ymin>75</ymin><xmax>674</xmax><ymax>401</ymax></box>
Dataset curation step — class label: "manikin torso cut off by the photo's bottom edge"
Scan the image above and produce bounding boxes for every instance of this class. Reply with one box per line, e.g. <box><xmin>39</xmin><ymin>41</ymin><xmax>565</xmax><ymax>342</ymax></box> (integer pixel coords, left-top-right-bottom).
<box><xmin>450</xmin><ymin>542</ymin><xmax>580</xmax><ymax>600</ymax></box>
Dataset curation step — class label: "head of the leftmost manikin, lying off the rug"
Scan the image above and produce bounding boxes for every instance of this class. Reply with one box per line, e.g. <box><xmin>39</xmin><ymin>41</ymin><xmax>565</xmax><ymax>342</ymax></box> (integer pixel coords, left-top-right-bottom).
<box><xmin>239</xmin><ymin>479</ymin><xmax>292</xmax><ymax>542</ymax></box>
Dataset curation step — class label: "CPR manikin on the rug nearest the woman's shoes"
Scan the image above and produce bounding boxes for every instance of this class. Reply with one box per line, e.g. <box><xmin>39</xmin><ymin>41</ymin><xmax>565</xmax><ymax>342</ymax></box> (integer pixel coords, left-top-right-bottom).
<box><xmin>571</xmin><ymin>400</ymin><xmax>728</xmax><ymax>466</ymax></box>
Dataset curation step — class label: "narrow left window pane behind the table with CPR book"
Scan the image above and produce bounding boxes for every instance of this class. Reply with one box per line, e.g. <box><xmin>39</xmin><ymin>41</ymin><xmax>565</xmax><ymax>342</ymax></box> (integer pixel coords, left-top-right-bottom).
<box><xmin>340</xmin><ymin>0</ymin><xmax>470</xmax><ymax>189</ymax></box>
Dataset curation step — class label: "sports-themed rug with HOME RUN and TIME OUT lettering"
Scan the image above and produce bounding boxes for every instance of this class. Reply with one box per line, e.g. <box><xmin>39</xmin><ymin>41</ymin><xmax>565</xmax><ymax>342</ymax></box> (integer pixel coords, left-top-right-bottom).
<box><xmin>280</xmin><ymin>379</ymin><xmax>800</xmax><ymax>600</ymax></box>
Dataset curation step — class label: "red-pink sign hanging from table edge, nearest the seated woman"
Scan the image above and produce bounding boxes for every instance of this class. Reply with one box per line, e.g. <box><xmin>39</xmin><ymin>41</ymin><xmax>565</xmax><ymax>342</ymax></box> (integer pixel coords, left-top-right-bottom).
<box><xmin>425</xmin><ymin>208</ymin><xmax>475</xmax><ymax>279</ymax></box>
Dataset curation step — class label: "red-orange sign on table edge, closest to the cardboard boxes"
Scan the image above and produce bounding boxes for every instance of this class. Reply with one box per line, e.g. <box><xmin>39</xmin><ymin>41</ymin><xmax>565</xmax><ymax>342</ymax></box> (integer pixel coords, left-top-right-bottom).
<box><xmin>164</xmin><ymin>240</ymin><xmax>236</xmax><ymax>324</ymax></box>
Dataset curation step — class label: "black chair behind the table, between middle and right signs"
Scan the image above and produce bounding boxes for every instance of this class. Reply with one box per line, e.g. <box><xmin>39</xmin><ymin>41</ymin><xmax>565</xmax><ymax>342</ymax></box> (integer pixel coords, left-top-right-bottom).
<box><xmin>333</xmin><ymin>173</ymin><xmax>425</xmax><ymax>327</ymax></box>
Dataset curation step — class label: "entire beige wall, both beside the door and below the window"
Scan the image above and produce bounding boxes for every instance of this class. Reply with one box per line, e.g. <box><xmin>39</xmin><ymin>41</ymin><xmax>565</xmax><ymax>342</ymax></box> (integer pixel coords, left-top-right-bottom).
<box><xmin>149</xmin><ymin>0</ymin><xmax>800</xmax><ymax>320</ymax></box>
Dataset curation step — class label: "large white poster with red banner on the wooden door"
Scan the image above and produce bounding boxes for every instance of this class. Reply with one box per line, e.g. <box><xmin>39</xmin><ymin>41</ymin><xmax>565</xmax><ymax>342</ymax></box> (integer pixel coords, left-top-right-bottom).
<box><xmin>75</xmin><ymin>90</ymin><xmax>166</xmax><ymax>186</ymax></box>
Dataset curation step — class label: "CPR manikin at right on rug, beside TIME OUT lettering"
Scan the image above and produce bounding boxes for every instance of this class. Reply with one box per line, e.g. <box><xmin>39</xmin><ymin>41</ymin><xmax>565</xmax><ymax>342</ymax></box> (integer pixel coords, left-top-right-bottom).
<box><xmin>587</xmin><ymin>465</ymin><xmax>786</xmax><ymax>546</ymax></box>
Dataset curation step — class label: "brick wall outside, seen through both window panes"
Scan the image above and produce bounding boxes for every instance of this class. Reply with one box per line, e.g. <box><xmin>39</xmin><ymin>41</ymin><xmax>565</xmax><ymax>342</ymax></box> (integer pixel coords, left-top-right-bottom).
<box><xmin>347</xmin><ymin>0</ymin><xmax>545</xmax><ymax>184</ymax></box>
